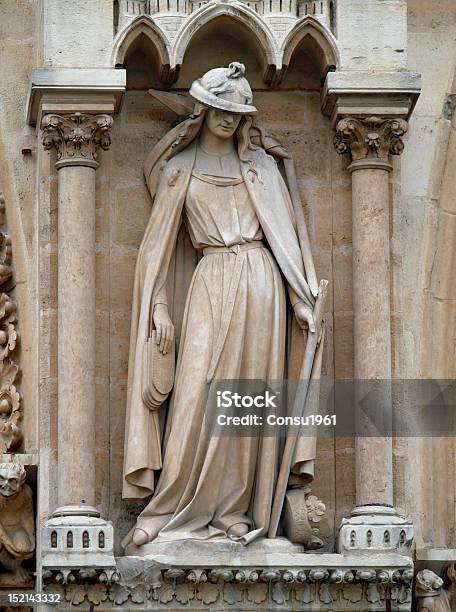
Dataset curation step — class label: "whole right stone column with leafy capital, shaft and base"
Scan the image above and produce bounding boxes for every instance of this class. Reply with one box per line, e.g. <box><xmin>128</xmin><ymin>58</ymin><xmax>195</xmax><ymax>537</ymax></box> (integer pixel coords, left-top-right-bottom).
<box><xmin>334</xmin><ymin>117</ymin><xmax>411</xmax><ymax>550</ymax></box>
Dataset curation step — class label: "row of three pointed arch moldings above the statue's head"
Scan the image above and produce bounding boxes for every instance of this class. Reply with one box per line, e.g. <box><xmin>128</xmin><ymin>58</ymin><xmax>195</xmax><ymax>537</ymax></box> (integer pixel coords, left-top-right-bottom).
<box><xmin>111</xmin><ymin>2</ymin><xmax>339</xmax><ymax>85</ymax></box>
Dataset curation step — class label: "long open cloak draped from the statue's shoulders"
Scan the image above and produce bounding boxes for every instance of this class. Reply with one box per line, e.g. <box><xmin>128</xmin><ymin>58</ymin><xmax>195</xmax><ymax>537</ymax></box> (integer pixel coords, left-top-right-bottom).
<box><xmin>123</xmin><ymin>137</ymin><xmax>315</xmax><ymax>540</ymax></box>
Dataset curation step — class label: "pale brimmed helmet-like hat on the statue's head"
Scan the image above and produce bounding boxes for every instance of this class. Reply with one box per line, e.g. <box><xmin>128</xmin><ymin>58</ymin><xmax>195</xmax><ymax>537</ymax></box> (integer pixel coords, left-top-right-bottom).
<box><xmin>189</xmin><ymin>62</ymin><xmax>257</xmax><ymax>115</ymax></box>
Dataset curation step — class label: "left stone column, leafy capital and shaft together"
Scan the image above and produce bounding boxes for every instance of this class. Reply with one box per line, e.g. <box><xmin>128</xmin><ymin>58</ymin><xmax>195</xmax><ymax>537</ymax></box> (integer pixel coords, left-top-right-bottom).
<box><xmin>41</xmin><ymin>113</ymin><xmax>113</xmax><ymax>514</ymax></box>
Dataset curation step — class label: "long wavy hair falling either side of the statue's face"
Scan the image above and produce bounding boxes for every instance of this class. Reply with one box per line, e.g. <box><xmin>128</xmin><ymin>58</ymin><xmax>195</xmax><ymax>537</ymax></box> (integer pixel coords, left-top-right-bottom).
<box><xmin>144</xmin><ymin>102</ymin><xmax>258</xmax><ymax>197</ymax></box>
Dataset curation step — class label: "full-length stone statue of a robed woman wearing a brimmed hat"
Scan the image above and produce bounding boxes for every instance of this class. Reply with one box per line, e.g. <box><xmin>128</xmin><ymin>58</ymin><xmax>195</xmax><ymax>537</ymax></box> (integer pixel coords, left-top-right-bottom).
<box><xmin>123</xmin><ymin>62</ymin><xmax>326</xmax><ymax>546</ymax></box>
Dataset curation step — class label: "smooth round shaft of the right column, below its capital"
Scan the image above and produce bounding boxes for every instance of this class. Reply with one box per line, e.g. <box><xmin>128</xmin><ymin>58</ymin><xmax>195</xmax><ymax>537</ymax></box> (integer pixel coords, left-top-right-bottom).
<box><xmin>351</xmin><ymin>164</ymin><xmax>393</xmax><ymax>506</ymax></box>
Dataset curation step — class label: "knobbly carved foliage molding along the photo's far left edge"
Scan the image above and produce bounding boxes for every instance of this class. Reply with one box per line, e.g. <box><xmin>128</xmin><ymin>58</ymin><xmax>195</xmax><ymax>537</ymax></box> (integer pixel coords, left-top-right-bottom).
<box><xmin>0</xmin><ymin>194</ymin><xmax>22</xmax><ymax>453</ymax></box>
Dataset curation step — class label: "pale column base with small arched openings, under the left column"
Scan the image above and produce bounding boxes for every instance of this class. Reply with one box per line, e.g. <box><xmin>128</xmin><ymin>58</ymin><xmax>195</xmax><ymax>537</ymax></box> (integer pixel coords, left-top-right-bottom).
<box><xmin>41</xmin><ymin>504</ymin><xmax>117</xmax><ymax>584</ymax></box>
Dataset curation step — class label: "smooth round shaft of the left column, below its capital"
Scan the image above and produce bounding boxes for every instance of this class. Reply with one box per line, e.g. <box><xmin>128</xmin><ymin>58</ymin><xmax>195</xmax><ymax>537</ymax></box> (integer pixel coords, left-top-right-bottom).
<box><xmin>58</xmin><ymin>166</ymin><xmax>95</xmax><ymax>506</ymax></box>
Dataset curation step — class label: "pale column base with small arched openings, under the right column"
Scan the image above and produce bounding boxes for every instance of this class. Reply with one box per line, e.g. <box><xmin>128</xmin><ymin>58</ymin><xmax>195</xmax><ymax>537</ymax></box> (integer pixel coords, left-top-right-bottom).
<box><xmin>337</xmin><ymin>504</ymin><xmax>414</xmax><ymax>555</ymax></box>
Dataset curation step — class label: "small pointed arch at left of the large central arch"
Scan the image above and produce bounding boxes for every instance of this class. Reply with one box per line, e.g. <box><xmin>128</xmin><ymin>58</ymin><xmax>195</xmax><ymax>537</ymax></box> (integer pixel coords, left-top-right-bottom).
<box><xmin>111</xmin><ymin>15</ymin><xmax>173</xmax><ymax>83</ymax></box>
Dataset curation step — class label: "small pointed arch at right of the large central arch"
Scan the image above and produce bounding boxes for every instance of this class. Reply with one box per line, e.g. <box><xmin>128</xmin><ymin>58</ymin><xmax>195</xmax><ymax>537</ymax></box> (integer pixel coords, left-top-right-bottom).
<box><xmin>280</xmin><ymin>15</ymin><xmax>339</xmax><ymax>76</ymax></box>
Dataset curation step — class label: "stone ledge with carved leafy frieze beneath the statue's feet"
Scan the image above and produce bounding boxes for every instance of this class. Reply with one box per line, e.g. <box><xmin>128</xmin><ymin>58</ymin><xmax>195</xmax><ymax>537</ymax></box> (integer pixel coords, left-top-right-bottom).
<box><xmin>41</xmin><ymin>550</ymin><xmax>413</xmax><ymax>612</ymax></box>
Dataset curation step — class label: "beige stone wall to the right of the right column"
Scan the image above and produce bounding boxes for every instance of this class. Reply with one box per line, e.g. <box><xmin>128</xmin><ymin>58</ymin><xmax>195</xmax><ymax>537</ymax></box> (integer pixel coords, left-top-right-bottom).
<box><xmin>392</xmin><ymin>0</ymin><xmax>456</xmax><ymax>548</ymax></box>
